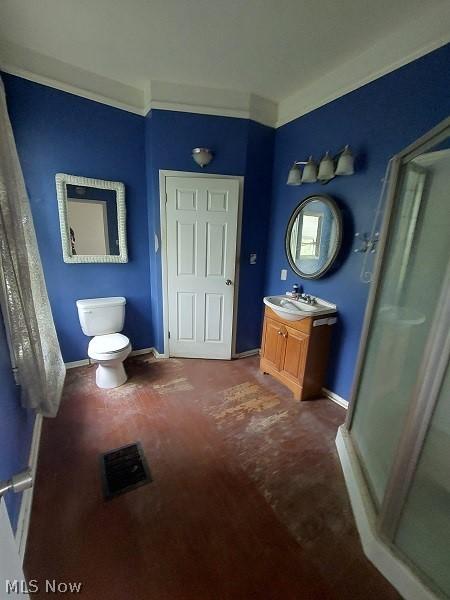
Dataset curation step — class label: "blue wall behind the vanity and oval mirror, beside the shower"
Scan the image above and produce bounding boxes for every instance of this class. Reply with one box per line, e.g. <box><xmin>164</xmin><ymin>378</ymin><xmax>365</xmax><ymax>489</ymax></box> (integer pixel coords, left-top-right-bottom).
<box><xmin>266</xmin><ymin>45</ymin><xmax>450</xmax><ymax>398</ymax></box>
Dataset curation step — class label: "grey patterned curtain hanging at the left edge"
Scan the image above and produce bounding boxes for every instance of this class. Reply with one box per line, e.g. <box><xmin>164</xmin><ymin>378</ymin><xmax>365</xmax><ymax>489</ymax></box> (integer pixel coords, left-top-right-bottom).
<box><xmin>0</xmin><ymin>79</ymin><xmax>66</xmax><ymax>417</ymax></box>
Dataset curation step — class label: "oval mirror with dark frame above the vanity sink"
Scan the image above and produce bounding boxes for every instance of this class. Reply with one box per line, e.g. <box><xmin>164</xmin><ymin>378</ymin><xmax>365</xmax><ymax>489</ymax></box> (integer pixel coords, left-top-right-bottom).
<box><xmin>285</xmin><ymin>195</ymin><xmax>342</xmax><ymax>279</ymax></box>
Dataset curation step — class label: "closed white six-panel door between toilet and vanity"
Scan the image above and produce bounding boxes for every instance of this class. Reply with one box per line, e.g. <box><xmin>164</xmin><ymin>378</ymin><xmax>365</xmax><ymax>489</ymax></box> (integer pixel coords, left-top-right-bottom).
<box><xmin>166</xmin><ymin>177</ymin><xmax>239</xmax><ymax>359</ymax></box>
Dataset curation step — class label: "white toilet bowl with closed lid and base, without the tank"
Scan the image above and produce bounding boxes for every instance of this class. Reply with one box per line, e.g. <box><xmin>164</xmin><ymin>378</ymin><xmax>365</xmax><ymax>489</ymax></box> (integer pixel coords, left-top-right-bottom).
<box><xmin>88</xmin><ymin>333</ymin><xmax>131</xmax><ymax>389</ymax></box>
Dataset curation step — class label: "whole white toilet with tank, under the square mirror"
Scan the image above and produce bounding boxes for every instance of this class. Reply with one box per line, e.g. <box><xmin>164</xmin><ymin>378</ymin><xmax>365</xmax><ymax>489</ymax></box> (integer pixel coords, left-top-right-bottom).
<box><xmin>77</xmin><ymin>296</ymin><xmax>131</xmax><ymax>389</ymax></box>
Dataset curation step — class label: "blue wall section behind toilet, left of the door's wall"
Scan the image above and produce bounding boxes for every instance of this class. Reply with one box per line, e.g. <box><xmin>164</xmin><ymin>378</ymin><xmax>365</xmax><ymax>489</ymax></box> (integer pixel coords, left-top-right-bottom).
<box><xmin>3</xmin><ymin>75</ymin><xmax>153</xmax><ymax>361</ymax></box>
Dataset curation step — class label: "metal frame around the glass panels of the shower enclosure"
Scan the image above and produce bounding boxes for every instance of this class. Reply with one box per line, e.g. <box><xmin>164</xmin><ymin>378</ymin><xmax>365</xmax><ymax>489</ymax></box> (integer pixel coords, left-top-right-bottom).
<box><xmin>338</xmin><ymin>118</ymin><xmax>450</xmax><ymax>592</ymax></box>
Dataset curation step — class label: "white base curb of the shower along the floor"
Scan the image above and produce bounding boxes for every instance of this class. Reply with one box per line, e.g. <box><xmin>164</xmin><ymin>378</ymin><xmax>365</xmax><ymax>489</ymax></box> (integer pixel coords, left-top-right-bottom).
<box><xmin>336</xmin><ymin>425</ymin><xmax>438</xmax><ymax>600</ymax></box>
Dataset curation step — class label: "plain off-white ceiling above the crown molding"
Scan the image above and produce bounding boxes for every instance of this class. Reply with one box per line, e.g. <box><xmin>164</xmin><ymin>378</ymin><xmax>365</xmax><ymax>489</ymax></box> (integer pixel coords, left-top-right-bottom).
<box><xmin>0</xmin><ymin>0</ymin><xmax>450</xmax><ymax>124</ymax></box>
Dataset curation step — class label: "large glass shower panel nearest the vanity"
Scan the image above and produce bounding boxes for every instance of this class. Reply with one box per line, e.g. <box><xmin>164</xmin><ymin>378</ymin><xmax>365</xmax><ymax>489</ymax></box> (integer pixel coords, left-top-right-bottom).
<box><xmin>351</xmin><ymin>149</ymin><xmax>450</xmax><ymax>507</ymax></box>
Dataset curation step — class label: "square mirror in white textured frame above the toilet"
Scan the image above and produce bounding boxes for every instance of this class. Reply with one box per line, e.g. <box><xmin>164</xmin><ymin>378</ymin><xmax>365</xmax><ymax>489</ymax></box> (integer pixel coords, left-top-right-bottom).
<box><xmin>55</xmin><ymin>173</ymin><xmax>128</xmax><ymax>263</ymax></box>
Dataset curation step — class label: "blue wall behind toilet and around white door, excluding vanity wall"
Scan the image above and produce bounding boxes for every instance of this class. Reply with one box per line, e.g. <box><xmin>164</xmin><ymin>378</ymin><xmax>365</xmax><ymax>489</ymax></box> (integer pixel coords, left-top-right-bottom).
<box><xmin>3</xmin><ymin>75</ymin><xmax>274</xmax><ymax>362</ymax></box>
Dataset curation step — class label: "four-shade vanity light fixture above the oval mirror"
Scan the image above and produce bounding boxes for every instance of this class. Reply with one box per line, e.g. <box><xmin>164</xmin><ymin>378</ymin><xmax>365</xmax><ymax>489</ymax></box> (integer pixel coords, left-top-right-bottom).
<box><xmin>286</xmin><ymin>146</ymin><xmax>355</xmax><ymax>185</ymax></box>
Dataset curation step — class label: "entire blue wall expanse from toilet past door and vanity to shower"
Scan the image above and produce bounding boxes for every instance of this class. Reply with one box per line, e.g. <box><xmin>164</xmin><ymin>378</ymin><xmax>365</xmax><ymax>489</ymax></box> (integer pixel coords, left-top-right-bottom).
<box><xmin>4</xmin><ymin>46</ymin><xmax>450</xmax><ymax>390</ymax></box>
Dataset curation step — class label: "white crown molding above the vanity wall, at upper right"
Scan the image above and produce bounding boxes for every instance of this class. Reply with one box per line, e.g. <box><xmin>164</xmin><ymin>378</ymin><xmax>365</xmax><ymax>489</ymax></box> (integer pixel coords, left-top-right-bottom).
<box><xmin>276</xmin><ymin>2</ymin><xmax>450</xmax><ymax>127</ymax></box>
